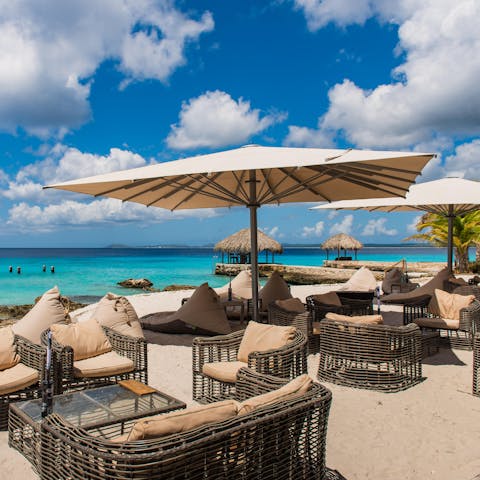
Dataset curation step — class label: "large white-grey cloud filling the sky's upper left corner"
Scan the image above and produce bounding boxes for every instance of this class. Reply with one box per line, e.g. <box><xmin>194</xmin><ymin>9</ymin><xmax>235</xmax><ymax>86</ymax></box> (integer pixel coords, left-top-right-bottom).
<box><xmin>0</xmin><ymin>0</ymin><xmax>213</xmax><ymax>136</ymax></box>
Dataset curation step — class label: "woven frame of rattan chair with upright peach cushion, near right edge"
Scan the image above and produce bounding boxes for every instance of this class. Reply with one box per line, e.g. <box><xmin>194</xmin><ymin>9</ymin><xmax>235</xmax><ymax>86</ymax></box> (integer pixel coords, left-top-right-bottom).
<box><xmin>403</xmin><ymin>285</ymin><xmax>480</xmax><ymax>350</ymax></box>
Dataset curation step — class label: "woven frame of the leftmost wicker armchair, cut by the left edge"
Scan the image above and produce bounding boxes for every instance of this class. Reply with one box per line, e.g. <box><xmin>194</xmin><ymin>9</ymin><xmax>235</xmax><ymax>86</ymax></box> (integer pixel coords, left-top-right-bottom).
<box><xmin>0</xmin><ymin>335</ymin><xmax>47</xmax><ymax>430</ymax></box>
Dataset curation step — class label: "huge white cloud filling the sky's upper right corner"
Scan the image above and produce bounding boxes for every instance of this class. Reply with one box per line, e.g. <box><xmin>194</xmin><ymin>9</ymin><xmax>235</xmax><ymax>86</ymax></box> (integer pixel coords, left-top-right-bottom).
<box><xmin>287</xmin><ymin>0</ymin><xmax>480</xmax><ymax>148</ymax></box>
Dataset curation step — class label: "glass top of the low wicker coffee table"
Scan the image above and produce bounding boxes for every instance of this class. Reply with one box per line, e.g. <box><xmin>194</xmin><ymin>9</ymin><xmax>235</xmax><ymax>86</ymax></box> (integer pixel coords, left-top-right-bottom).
<box><xmin>16</xmin><ymin>385</ymin><xmax>185</xmax><ymax>427</ymax></box>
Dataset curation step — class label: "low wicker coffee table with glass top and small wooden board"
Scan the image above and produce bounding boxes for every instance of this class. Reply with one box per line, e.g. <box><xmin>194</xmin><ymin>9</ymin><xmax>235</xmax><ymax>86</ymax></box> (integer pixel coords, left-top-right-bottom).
<box><xmin>8</xmin><ymin>381</ymin><xmax>186</xmax><ymax>468</ymax></box>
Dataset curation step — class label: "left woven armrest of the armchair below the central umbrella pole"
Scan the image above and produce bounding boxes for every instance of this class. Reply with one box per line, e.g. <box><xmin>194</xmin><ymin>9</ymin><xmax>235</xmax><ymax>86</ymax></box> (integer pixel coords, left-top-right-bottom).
<box><xmin>192</xmin><ymin>330</ymin><xmax>244</xmax><ymax>373</ymax></box>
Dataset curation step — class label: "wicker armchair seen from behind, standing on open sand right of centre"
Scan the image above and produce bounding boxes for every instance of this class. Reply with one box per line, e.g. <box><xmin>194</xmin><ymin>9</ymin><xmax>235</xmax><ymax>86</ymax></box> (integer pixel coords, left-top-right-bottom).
<box><xmin>318</xmin><ymin>319</ymin><xmax>422</xmax><ymax>392</ymax></box>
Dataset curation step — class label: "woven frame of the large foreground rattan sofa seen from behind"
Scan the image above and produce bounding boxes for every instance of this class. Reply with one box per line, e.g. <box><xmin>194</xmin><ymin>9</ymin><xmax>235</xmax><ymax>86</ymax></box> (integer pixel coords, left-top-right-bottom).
<box><xmin>41</xmin><ymin>368</ymin><xmax>338</xmax><ymax>480</ymax></box>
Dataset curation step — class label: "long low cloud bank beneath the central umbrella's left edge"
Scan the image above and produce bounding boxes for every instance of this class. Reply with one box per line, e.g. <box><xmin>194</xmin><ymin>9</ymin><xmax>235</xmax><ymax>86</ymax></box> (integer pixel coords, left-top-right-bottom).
<box><xmin>7</xmin><ymin>198</ymin><xmax>216</xmax><ymax>232</ymax></box>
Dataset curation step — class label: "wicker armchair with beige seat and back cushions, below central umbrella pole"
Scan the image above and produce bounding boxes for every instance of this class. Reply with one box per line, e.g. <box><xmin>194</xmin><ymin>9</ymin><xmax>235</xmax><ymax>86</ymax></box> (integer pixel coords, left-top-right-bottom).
<box><xmin>192</xmin><ymin>321</ymin><xmax>307</xmax><ymax>403</ymax></box>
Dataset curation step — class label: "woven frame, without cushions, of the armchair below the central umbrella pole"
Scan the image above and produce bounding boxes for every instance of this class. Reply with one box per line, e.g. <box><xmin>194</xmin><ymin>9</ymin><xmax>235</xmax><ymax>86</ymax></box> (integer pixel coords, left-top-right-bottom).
<box><xmin>192</xmin><ymin>330</ymin><xmax>307</xmax><ymax>403</ymax></box>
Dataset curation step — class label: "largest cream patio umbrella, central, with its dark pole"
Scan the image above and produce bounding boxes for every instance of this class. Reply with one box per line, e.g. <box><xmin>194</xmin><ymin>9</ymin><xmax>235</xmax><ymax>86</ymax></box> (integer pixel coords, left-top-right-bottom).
<box><xmin>46</xmin><ymin>145</ymin><xmax>433</xmax><ymax>319</ymax></box>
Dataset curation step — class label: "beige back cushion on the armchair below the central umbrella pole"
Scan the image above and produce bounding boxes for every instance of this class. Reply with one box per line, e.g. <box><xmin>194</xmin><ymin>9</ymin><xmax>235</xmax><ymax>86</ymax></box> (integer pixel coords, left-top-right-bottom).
<box><xmin>237</xmin><ymin>321</ymin><xmax>296</xmax><ymax>363</ymax></box>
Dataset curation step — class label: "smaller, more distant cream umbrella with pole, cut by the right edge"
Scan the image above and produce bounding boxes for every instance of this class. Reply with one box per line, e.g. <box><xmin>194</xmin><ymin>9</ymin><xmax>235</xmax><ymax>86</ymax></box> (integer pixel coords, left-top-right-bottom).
<box><xmin>312</xmin><ymin>177</ymin><xmax>480</xmax><ymax>272</ymax></box>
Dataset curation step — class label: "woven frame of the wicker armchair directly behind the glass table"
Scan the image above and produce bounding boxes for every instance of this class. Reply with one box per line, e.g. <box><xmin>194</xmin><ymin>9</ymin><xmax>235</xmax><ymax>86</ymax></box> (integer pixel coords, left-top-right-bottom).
<box><xmin>42</xmin><ymin>327</ymin><xmax>148</xmax><ymax>394</ymax></box>
